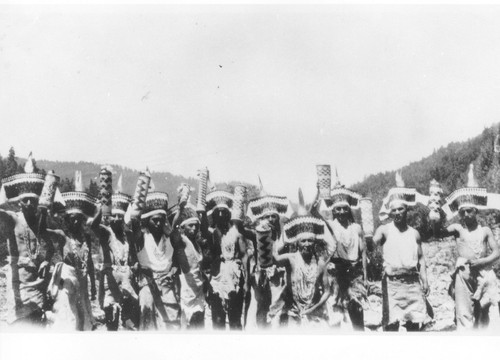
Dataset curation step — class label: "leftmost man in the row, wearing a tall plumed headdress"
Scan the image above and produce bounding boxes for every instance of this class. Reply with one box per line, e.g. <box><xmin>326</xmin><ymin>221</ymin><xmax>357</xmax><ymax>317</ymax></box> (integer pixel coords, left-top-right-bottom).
<box><xmin>0</xmin><ymin>154</ymin><xmax>54</xmax><ymax>324</ymax></box>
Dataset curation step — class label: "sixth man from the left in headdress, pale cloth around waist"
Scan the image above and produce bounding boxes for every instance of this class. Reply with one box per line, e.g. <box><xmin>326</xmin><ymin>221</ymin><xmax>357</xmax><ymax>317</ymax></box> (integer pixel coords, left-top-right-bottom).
<box><xmin>206</xmin><ymin>190</ymin><xmax>248</xmax><ymax>330</ymax></box>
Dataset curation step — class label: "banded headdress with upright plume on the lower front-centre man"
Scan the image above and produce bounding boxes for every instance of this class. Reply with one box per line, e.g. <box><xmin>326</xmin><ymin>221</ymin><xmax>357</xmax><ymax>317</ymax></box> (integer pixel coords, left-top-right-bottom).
<box><xmin>283</xmin><ymin>189</ymin><xmax>325</xmax><ymax>243</ymax></box>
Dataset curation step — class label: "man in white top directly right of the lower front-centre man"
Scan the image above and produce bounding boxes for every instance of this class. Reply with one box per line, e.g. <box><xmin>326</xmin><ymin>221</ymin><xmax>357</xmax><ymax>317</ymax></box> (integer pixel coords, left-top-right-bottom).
<box><xmin>315</xmin><ymin>181</ymin><xmax>367</xmax><ymax>331</ymax></box>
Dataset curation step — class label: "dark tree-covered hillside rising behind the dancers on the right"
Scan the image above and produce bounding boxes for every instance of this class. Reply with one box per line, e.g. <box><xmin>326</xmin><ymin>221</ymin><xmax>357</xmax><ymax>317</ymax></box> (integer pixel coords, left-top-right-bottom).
<box><xmin>351</xmin><ymin>125</ymin><xmax>500</xmax><ymax>219</ymax></box>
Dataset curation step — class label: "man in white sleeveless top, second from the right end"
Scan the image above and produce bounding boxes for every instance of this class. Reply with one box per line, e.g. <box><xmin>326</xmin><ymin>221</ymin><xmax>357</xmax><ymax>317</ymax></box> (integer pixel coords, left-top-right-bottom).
<box><xmin>373</xmin><ymin>187</ymin><xmax>429</xmax><ymax>331</ymax></box>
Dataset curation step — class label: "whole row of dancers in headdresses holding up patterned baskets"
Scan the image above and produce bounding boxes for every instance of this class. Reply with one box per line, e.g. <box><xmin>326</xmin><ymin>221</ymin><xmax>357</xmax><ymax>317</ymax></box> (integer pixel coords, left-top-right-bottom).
<box><xmin>0</xmin><ymin>156</ymin><xmax>500</xmax><ymax>331</ymax></box>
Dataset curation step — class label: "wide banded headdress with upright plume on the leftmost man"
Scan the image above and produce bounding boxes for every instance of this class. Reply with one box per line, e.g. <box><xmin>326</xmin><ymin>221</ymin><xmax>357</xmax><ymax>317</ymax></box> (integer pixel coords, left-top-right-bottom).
<box><xmin>0</xmin><ymin>153</ymin><xmax>45</xmax><ymax>202</ymax></box>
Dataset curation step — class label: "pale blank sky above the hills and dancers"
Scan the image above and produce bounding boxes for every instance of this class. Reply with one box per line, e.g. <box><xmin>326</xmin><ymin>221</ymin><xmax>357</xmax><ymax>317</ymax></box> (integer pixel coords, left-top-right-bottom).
<box><xmin>0</xmin><ymin>5</ymin><xmax>500</xmax><ymax>200</ymax></box>
